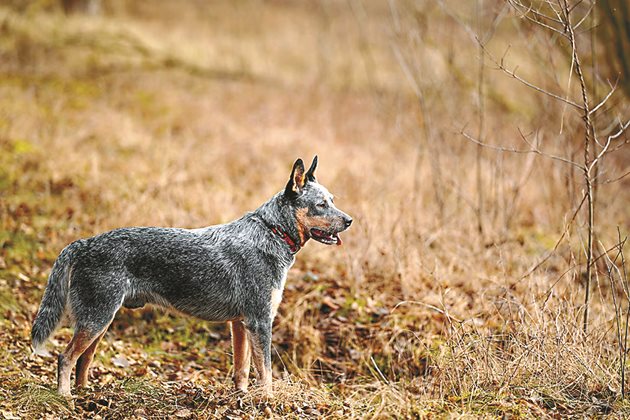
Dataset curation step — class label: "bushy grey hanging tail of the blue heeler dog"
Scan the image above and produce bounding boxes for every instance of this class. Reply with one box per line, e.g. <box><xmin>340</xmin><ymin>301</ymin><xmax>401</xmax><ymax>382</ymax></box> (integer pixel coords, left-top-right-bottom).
<box><xmin>31</xmin><ymin>242</ymin><xmax>78</xmax><ymax>353</ymax></box>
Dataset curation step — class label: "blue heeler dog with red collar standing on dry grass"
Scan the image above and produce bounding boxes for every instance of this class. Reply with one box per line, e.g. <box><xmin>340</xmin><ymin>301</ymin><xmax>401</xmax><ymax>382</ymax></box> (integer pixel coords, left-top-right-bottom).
<box><xmin>31</xmin><ymin>156</ymin><xmax>352</xmax><ymax>396</ymax></box>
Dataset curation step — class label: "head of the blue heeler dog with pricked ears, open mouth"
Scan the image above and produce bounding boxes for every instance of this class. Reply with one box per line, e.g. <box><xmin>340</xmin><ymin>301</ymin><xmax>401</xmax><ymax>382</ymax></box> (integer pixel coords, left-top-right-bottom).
<box><xmin>284</xmin><ymin>156</ymin><xmax>352</xmax><ymax>245</ymax></box>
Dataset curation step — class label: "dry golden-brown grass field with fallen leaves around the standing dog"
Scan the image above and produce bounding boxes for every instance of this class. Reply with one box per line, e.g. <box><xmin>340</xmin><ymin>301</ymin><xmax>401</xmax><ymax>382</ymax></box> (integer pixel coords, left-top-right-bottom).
<box><xmin>0</xmin><ymin>0</ymin><xmax>630</xmax><ymax>419</ymax></box>
